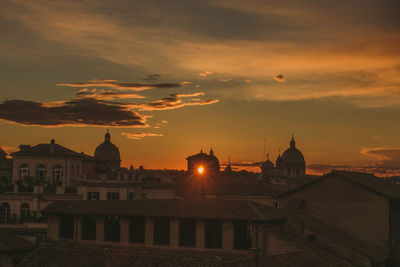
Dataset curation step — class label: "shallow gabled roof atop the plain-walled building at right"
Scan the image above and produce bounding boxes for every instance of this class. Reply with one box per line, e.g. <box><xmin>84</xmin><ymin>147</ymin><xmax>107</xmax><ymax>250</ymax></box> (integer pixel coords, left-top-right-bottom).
<box><xmin>276</xmin><ymin>171</ymin><xmax>400</xmax><ymax>199</ymax></box>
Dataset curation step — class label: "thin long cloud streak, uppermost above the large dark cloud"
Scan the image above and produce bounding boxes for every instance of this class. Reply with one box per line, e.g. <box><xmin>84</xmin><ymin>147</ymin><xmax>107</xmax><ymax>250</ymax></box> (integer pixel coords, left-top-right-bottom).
<box><xmin>57</xmin><ymin>79</ymin><xmax>181</xmax><ymax>91</ymax></box>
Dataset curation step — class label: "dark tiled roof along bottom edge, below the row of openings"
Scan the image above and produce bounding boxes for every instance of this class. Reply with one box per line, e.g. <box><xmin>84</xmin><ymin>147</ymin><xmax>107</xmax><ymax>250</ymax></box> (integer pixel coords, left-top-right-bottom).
<box><xmin>18</xmin><ymin>242</ymin><xmax>247</xmax><ymax>267</ymax></box>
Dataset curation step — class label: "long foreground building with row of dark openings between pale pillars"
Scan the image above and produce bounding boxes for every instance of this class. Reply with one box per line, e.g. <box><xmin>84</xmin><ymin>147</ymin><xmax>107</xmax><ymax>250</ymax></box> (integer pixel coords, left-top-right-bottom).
<box><xmin>20</xmin><ymin>198</ymin><xmax>390</xmax><ymax>267</ymax></box>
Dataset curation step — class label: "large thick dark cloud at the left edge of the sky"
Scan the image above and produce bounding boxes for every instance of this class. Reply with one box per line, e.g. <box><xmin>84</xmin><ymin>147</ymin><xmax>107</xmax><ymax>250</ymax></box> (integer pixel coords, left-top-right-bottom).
<box><xmin>0</xmin><ymin>98</ymin><xmax>148</xmax><ymax>127</ymax></box>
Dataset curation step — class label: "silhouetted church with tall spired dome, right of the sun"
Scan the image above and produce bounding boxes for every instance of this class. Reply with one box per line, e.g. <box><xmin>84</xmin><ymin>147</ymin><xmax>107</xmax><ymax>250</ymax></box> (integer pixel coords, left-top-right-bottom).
<box><xmin>261</xmin><ymin>136</ymin><xmax>306</xmax><ymax>183</ymax></box>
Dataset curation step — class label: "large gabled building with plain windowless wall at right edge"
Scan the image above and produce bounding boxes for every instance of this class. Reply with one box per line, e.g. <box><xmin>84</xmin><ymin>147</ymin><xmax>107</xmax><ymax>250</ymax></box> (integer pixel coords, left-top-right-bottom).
<box><xmin>276</xmin><ymin>171</ymin><xmax>400</xmax><ymax>266</ymax></box>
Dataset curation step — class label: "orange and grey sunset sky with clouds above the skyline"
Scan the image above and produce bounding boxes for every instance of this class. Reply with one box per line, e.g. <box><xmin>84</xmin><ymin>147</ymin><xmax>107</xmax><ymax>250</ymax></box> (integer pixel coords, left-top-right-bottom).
<box><xmin>0</xmin><ymin>0</ymin><xmax>400</xmax><ymax>173</ymax></box>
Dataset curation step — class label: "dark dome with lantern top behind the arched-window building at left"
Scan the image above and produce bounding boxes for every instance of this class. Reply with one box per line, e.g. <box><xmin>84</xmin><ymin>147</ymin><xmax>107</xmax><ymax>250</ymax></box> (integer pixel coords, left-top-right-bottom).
<box><xmin>94</xmin><ymin>129</ymin><xmax>121</xmax><ymax>172</ymax></box>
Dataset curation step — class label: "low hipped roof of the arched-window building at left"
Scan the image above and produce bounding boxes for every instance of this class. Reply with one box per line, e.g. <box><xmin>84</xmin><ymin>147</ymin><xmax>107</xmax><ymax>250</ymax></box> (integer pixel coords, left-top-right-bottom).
<box><xmin>11</xmin><ymin>143</ymin><xmax>91</xmax><ymax>158</ymax></box>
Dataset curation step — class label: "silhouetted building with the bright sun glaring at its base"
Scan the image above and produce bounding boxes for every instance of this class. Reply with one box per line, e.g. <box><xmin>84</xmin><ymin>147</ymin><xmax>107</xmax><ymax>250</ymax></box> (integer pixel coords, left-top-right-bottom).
<box><xmin>186</xmin><ymin>148</ymin><xmax>220</xmax><ymax>175</ymax></box>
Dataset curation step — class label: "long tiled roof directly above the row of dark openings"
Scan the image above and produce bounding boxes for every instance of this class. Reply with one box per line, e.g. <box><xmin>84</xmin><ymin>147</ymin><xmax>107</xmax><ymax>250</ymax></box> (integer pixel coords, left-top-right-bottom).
<box><xmin>43</xmin><ymin>198</ymin><xmax>282</xmax><ymax>221</ymax></box>
